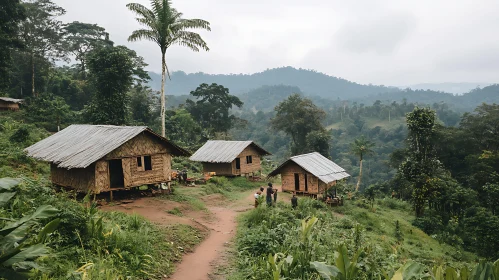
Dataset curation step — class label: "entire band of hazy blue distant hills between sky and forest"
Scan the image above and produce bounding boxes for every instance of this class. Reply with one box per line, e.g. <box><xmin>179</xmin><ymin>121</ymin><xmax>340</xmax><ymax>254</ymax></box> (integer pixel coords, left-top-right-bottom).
<box><xmin>149</xmin><ymin>67</ymin><xmax>499</xmax><ymax>111</ymax></box>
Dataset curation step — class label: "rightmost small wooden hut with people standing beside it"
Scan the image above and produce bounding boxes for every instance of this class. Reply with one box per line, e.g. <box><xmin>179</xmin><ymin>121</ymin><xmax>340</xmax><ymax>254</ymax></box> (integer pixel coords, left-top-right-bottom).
<box><xmin>269</xmin><ymin>152</ymin><xmax>350</xmax><ymax>196</ymax></box>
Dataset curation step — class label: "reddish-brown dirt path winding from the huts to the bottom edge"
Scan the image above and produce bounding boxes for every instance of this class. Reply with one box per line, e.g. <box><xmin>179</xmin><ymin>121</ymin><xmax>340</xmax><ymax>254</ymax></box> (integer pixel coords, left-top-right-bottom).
<box><xmin>102</xmin><ymin>186</ymin><xmax>290</xmax><ymax>280</ymax></box>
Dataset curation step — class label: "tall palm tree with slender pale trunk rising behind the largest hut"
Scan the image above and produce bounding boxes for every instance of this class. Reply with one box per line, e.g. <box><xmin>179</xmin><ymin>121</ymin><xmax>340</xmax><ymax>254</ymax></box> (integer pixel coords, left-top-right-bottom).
<box><xmin>126</xmin><ymin>0</ymin><xmax>211</xmax><ymax>137</ymax></box>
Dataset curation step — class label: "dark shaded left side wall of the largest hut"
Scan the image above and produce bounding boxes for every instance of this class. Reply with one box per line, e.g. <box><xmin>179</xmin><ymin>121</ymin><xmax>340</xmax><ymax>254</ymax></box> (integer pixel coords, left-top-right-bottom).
<box><xmin>50</xmin><ymin>164</ymin><xmax>95</xmax><ymax>192</ymax></box>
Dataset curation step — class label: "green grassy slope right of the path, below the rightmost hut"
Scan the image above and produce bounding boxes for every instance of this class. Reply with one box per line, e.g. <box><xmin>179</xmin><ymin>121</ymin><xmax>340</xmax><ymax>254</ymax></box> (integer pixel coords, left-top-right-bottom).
<box><xmin>228</xmin><ymin>197</ymin><xmax>477</xmax><ymax>280</ymax></box>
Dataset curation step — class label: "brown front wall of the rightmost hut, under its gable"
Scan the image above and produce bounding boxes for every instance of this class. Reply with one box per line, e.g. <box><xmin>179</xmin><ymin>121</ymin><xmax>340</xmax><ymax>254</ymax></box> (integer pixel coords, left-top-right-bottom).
<box><xmin>281</xmin><ymin>162</ymin><xmax>326</xmax><ymax>194</ymax></box>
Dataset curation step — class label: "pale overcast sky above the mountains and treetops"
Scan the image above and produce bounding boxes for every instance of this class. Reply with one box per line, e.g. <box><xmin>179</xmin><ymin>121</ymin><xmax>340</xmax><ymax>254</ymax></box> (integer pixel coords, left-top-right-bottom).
<box><xmin>54</xmin><ymin>0</ymin><xmax>499</xmax><ymax>85</ymax></box>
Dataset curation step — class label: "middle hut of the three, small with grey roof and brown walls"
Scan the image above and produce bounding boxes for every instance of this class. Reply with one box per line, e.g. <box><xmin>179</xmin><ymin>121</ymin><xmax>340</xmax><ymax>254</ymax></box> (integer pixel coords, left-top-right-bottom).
<box><xmin>190</xmin><ymin>140</ymin><xmax>270</xmax><ymax>176</ymax></box>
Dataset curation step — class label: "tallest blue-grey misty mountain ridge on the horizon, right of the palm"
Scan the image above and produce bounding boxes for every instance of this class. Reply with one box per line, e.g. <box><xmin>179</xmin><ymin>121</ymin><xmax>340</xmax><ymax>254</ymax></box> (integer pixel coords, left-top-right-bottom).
<box><xmin>149</xmin><ymin>67</ymin><xmax>399</xmax><ymax>99</ymax></box>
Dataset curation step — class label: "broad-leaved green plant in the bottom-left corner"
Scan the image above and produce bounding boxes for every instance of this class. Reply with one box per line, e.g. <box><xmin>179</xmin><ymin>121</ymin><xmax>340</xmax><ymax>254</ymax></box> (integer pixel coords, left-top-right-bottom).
<box><xmin>0</xmin><ymin>178</ymin><xmax>60</xmax><ymax>279</ymax></box>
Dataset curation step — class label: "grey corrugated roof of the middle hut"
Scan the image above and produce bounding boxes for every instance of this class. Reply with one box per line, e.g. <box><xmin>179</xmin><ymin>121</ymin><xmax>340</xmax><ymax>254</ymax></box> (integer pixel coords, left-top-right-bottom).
<box><xmin>190</xmin><ymin>140</ymin><xmax>270</xmax><ymax>163</ymax></box>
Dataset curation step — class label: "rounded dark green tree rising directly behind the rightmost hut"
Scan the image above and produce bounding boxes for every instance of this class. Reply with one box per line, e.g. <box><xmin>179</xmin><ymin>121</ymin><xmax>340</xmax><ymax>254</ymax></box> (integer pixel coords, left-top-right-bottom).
<box><xmin>270</xmin><ymin>94</ymin><xmax>326</xmax><ymax>155</ymax></box>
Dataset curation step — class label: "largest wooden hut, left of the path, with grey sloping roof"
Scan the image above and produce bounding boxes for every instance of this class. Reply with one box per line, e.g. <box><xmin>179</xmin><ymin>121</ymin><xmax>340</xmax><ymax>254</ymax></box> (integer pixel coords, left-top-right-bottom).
<box><xmin>25</xmin><ymin>125</ymin><xmax>190</xmax><ymax>193</ymax></box>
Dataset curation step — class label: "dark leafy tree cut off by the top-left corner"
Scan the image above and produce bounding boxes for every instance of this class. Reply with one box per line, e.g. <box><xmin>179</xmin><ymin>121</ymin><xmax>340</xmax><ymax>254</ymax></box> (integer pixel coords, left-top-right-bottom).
<box><xmin>0</xmin><ymin>0</ymin><xmax>26</xmax><ymax>88</ymax></box>
